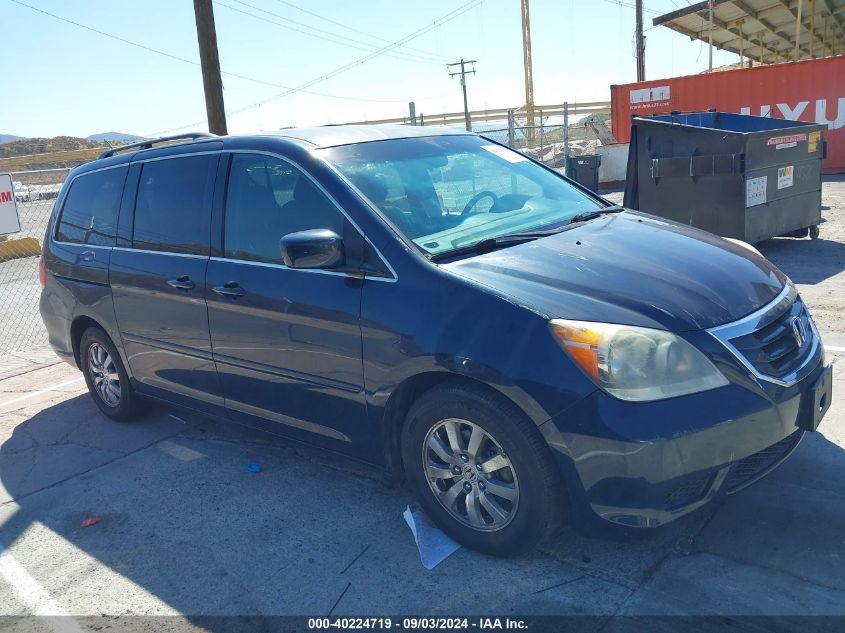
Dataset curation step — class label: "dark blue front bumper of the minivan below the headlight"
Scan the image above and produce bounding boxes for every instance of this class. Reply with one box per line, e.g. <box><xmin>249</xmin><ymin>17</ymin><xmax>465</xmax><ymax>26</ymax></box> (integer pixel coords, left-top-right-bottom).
<box><xmin>540</xmin><ymin>354</ymin><xmax>829</xmax><ymax>527</ymax></box>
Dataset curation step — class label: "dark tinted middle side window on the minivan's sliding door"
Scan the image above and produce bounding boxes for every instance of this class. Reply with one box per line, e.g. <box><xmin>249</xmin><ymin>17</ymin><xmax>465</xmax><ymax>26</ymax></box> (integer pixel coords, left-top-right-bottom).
<box><xmin>132</xmin><ymin>154</ymin><xmax>217</xmax><ymax>255</ymax></box>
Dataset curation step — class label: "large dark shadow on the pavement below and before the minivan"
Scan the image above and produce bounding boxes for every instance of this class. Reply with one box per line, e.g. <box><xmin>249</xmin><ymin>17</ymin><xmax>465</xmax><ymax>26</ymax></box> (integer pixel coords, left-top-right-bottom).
<box><xmin>0</xmin><ymin>395</ymin><xmax>845</xmax><ymax>625</ymax></box>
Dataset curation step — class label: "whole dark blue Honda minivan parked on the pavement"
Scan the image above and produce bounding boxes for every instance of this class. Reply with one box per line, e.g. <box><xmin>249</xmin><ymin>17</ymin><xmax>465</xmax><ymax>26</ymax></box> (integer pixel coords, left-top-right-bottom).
<box><xmin>41</xmin><ymin>126</ymin><xmax>831</xmax><ymax>554</ymax></box>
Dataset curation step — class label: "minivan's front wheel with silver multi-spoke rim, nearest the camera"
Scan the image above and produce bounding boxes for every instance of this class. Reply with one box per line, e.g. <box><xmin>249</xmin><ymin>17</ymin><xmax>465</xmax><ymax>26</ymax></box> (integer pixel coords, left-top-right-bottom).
<box><xmin>402</xmin><ymin>385</ymin><xmax>566</xmax><ymax>556</ymax></box>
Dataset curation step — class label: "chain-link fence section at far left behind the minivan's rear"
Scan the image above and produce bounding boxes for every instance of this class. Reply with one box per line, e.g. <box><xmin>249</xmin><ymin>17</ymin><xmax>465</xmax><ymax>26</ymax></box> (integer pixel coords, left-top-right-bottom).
<box><xmin>0</xmin><ymin>169</ymin><xmax>70</xmax><ymax>355</ymax></box>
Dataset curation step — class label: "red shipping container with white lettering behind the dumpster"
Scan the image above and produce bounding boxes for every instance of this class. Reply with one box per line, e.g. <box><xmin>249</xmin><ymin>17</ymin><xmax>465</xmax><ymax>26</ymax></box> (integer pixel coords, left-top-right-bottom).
<box><xmin>610</xmin><ymin>55</ymin><xmax>845</xmax><ymax>173</ymax></box>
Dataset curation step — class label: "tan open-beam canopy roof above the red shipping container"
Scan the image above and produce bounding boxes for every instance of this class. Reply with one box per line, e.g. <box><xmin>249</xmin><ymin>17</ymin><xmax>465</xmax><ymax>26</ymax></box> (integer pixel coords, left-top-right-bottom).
<box><xmin>654</xmin><ymin>0</ymin><xmax>845</xmax><ymax>64</ymax></box>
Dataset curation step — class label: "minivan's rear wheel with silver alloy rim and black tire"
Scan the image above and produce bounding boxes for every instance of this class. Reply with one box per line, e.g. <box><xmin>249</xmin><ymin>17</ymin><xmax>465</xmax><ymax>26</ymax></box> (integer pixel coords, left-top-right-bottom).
<box><xmin>79</xmin><ymin>327</ymin><xmax>142</xmax><ymax>420</ymax></box>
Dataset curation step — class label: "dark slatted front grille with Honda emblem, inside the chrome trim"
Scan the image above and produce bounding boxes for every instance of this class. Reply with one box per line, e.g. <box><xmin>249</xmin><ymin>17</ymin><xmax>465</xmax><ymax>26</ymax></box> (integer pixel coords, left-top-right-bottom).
<box><xmin>730</xmin><ymin>299</ymin><xmax>815</xmax><ymax>378</ymax></box>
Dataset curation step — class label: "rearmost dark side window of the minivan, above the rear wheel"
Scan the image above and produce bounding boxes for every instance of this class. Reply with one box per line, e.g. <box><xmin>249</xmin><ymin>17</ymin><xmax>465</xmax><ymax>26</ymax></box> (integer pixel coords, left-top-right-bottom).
<box><xmin>56</xmin><ymin>167</ymin><xmax>127</xmax><ymax>246</ymax></box>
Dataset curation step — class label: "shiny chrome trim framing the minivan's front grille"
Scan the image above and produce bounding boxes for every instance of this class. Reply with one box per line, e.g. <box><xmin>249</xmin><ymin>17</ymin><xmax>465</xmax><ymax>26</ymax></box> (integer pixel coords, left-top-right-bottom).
<box><xmin>707</xmin><ymin>281</ymin><xmax>821</xmax><ymax>387</ymax></box>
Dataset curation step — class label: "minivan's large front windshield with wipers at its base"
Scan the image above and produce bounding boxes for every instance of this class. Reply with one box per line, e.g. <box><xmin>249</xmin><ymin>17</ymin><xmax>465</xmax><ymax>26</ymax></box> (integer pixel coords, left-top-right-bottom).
<box><xmin>321</xmin><ymin>135</ymin><xmax>602</xmax><ymax>255</ymax></box>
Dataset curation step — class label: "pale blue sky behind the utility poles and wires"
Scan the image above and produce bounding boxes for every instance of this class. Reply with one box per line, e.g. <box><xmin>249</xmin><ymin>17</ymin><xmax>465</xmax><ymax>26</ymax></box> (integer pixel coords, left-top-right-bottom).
<box><xmin>0</xmin><ymin>0</ymin><xmax>738</xmax><ymax>137</ymax></box>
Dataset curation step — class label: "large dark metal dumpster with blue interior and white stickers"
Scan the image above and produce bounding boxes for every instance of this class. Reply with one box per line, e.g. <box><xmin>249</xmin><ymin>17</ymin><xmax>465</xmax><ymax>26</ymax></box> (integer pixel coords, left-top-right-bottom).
<box><xmin>624</xmin><ymin>111</ymin><xmax>826</xmax><ymax>243</ymax></box>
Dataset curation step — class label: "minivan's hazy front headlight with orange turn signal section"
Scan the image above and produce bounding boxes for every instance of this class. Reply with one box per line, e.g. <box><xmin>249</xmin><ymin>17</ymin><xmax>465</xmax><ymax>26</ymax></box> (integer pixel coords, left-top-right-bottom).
<box><xmin>549</xmin><ymin>319</ymin><xmax>728</xmax><ymax>401</ymax></box>
